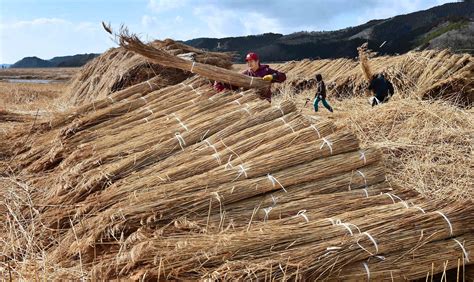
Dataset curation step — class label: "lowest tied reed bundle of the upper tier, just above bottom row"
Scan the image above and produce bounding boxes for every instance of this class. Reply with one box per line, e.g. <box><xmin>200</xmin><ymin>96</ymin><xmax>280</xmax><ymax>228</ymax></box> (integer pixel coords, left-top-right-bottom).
<box><xmin>195</xmin><ymin>163</ymin><xmax>393</xmax><ymax>231</ymax></box>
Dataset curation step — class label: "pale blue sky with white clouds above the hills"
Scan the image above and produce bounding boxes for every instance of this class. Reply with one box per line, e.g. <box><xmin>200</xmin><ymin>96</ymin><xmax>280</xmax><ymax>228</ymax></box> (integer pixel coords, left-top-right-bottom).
<box><xmin>0</xmin><ymin>0</ymin><xmax>453</xmax><ymax>64</ymax></box>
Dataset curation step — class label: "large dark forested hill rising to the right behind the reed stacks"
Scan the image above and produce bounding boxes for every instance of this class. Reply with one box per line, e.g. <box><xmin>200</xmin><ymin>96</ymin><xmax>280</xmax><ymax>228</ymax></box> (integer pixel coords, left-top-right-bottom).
<box><xmin>185</xmin><ymin>1</ymin><xmax>474</xmax><ymax>61</ymax></box>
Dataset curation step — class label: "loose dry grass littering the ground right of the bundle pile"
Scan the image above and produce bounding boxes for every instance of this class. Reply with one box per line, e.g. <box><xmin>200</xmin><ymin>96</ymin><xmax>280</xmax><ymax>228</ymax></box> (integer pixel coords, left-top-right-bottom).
<box><xmin>286</xmin><ymin>94</ymin><xmax>474</xmax><ymax>202</ymax></box>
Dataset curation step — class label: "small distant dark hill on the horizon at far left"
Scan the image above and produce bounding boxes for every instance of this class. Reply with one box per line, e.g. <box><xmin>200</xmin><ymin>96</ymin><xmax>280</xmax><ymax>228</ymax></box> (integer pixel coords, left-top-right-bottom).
<box><xmin>10</xmin><ymin>53</ymin><xmax>100</xmax><ymax>68</ymax></box>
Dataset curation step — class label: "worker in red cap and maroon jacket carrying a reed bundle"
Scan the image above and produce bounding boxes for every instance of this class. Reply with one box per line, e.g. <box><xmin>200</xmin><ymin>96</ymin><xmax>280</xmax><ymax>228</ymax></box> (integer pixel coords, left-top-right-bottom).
<box><xmin>214</xmin><ymin>52</ymin><xmax>286</xmax><ymax>102</ymax></box>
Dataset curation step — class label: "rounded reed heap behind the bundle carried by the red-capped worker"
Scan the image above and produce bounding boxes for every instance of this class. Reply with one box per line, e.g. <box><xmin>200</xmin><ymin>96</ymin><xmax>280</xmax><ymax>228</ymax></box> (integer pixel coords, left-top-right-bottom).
<box><xmin>68</xmin><ymin>39</ymin><xmax>232</xmax><ymax>105</ymax></box>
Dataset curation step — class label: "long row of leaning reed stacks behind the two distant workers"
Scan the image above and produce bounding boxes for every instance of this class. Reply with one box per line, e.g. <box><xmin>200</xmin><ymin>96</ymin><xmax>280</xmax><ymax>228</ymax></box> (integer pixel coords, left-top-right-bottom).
<box><xmin>277</xmin><ymin>46</ymin><xmax>474</xmax><ymax>106</ymax></box>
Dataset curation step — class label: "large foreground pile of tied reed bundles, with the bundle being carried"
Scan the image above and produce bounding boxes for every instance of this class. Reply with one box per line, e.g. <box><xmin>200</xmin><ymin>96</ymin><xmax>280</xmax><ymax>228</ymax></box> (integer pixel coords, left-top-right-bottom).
<box><xmin>0</xmin><ymin>33</ymin><xmax>474</xmax><ymax>280</ymax></box>
